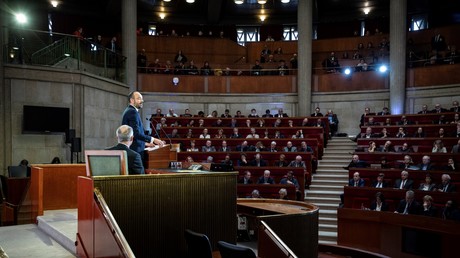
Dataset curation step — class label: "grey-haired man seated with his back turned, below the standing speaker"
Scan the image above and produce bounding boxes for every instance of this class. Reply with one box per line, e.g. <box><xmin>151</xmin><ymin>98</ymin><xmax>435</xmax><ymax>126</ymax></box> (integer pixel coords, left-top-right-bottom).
<box><xmin>108</xmin><ymin>125</ymin><xmax>145</xmax><ymax>175</ymax></box>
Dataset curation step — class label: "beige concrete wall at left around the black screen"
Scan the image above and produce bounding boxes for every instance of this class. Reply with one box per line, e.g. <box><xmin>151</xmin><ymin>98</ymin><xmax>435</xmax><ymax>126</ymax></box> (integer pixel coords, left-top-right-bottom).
<box><xmin>0</xmin><ymin>65</ymin><xmax>129</xmax><ymax>174</ymax></box>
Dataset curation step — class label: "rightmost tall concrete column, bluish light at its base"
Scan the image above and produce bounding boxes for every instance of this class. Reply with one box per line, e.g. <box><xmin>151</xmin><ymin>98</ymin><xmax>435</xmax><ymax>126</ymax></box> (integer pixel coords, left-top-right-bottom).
<box><xmin>389</xmin><ymin>0</ymin><xmax>407</xmax><ymax>115</ymax></box>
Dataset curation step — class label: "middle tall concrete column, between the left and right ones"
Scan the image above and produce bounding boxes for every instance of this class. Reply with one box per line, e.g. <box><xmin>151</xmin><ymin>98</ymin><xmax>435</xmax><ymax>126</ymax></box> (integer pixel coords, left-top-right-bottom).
<box><xmin>297</xmin><ymin>0</ymin><xmax>313</xmax><ymax>116</ymax></box>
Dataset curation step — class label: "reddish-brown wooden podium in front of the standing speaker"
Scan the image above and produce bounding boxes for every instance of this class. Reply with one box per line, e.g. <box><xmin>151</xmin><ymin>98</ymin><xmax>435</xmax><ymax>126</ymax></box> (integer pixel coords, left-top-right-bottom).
<box><xmin>144</xmin><ymin>144</ymin><xmax>179</xmax><ymax>169</ymax></box>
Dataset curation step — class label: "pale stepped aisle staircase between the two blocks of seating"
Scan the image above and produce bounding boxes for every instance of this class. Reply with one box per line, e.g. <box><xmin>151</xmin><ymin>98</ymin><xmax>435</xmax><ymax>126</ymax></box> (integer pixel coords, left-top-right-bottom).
<box><xmin>305</xmin><ymin>137</ymin><xmax>356</xmax><ymax>244</ymax></box>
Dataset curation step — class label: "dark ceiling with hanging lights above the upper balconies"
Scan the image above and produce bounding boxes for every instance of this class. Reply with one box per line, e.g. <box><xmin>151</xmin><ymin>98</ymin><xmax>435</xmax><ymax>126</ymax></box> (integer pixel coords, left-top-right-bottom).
<box><xmin>3</xmin><ymin>0</ymin><xmax>460</xmax><ymax>33</ymax></box>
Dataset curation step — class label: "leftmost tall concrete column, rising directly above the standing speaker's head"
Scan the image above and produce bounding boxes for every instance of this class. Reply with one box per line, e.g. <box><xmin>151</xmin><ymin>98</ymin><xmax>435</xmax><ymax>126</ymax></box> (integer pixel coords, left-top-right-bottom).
<box><xmin>121</xmin><ymin>0</ymin><xmax>137</xmax><ymax>91</ymax></box>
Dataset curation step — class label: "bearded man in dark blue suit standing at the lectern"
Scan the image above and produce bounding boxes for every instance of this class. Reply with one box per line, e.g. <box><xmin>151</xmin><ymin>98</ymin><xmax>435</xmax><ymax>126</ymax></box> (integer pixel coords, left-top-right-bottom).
<box><xmin>121</xmin><ymin>91</ymin><xmax>165</xmax><ymax>161</ymax></box>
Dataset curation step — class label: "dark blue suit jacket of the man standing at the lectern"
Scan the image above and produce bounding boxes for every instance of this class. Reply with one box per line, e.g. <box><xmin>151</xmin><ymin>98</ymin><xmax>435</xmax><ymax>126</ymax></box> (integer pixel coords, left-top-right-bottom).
<box><xmin>121</xmin><ymin>105</ymin><xmax>152</xmax><ymax>157</ymax></box>
